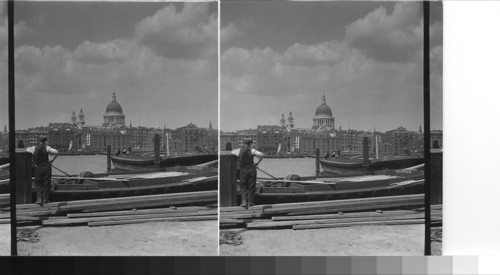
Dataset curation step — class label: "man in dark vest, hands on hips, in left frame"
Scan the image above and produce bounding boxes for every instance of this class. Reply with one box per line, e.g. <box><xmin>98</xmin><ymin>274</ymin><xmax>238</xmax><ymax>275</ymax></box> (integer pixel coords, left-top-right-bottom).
<box><xmin>26</xmin><ymin>136</ymin><xmax>59</xmax><ymax>206</ymax></box>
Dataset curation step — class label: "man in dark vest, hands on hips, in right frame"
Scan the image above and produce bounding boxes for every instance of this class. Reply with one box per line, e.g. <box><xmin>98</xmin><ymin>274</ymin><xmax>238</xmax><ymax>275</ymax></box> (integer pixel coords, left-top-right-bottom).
<box><xmin>231</xmin><ymin>138</ymin><xmax>264</xmax><ymax>209</ymax></box>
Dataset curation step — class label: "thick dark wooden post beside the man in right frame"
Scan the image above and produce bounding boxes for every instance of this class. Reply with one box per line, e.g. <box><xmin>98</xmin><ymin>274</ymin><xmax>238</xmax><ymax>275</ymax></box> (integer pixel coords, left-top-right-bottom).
<box><xmin>219</xmin><ymin>151</ymin><xmax>237</xmax><ymax>207</ymax></box>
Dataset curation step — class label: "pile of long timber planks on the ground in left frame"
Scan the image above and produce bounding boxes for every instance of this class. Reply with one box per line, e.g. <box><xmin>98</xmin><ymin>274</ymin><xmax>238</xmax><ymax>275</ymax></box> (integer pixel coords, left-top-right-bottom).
<box><xmin>0</xmin><ymin>191</ymin><xmax>217</xmax><ymax>226</ymax></box>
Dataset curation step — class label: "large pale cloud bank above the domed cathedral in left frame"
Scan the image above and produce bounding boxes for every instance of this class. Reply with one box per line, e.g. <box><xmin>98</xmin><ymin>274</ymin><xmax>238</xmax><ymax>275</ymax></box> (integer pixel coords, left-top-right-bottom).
<box><xmin>12</xmin><ymin>3</ymin><xmax>218</xmax><ymax>128</ymax></box>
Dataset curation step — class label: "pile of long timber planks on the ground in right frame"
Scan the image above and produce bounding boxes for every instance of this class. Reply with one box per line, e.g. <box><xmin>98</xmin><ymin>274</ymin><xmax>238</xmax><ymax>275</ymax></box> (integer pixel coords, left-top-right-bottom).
<box><xmin>220</xmin><ymin>194</ymin><xmax>425</xmax><ymax>230</ymax></box>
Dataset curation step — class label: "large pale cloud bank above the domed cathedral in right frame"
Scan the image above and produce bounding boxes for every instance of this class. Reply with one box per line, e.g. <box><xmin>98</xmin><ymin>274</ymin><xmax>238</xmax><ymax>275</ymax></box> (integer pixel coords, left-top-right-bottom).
<box><xmin>220</xmin><ymin>2</ymin><xmax>442</xmax><ymax>130</ymax></box>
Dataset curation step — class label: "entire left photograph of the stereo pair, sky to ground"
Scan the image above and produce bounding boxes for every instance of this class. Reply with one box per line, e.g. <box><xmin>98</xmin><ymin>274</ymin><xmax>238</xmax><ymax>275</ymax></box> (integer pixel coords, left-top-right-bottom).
<box><xmin>11</xmin><ymin>1</ymin><xmax>219</xmax><ymax>256</ymax></box>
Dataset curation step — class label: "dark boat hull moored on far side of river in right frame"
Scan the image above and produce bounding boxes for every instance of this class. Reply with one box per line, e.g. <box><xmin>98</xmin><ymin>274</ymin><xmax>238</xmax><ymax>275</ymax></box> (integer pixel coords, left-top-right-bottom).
<box><xmin>319</xmin><ymin>158</ymin><xmax>425</xmax><ymax>174</ymax></box>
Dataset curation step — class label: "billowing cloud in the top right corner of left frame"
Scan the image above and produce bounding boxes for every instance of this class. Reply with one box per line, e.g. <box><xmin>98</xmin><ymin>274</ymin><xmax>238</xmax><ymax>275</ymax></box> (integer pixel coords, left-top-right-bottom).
<box><xmin>135</xmin><ymin>3</ymin><xmax>218</xmax><ymax>59</ymax></box>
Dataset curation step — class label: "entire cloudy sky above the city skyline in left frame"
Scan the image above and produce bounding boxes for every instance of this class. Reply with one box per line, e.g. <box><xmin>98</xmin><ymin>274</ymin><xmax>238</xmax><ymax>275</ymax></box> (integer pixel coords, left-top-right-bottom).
<box><xmin>5</xmin><ymin>1</ymin><xmax>218</xmax><ymax>129</ymax></box>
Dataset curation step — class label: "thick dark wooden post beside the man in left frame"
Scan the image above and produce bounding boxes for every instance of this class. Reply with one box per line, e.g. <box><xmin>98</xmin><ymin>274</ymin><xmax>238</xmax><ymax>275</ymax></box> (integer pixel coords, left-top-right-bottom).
<box><xmin>16</xmin><ymin>149</ymin><xmax>33</xmax><ymax>204</ymax></box>
